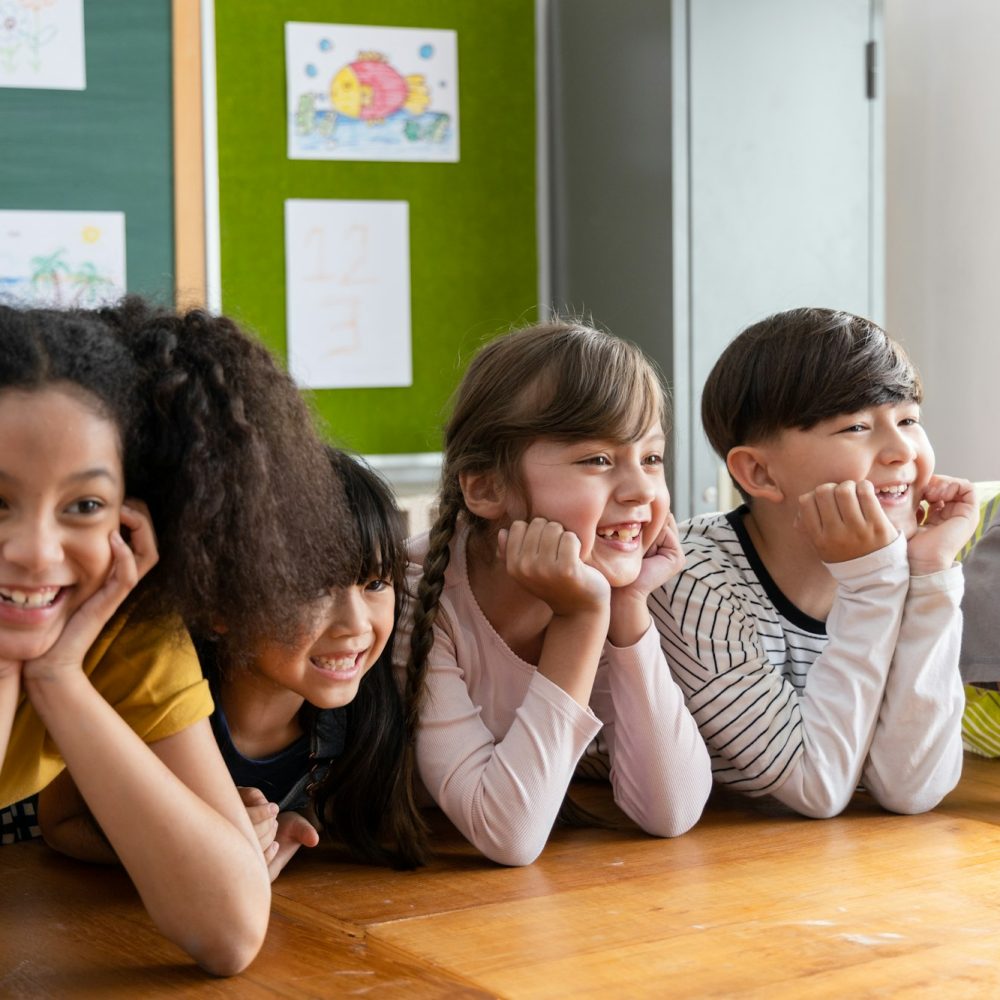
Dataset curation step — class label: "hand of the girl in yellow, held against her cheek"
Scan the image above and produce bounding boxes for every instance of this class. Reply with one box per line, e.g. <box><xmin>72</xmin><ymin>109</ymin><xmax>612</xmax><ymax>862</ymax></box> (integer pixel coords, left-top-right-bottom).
<box><xmin>24</xmin><ymin>500</ymin><xmax>159</xmax><ymax>680</ymax></box>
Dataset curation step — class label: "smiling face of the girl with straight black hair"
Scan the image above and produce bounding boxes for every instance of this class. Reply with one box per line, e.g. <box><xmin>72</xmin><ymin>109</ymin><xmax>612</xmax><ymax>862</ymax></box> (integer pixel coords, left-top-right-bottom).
<box><xmin>252</xmin><ymin>578</ymin><xmax>395</xmax><ymax>708</ymax></box>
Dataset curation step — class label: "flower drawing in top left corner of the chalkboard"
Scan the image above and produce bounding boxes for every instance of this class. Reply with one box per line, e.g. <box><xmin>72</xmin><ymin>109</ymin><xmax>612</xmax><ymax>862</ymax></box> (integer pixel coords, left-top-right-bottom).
<box><xmin>0</xmin><ymin>0</ymin><xmax>87</xmax><ymax>90</ymax></box>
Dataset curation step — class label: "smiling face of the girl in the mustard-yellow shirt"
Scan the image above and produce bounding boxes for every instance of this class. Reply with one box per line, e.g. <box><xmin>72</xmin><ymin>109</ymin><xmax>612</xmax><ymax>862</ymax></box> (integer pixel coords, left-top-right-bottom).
<box><xmin>0</xmin><ymin>387</ymin><xmax>125</xmax><ymax>661</ymax></box>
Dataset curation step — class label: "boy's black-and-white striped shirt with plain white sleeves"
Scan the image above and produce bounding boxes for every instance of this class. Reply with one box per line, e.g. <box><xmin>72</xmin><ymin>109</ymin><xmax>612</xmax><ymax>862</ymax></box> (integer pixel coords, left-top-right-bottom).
<box><xmin>649</xmin><ymin>508</ymin><xmax>961</xmax><ymax>816</ymax></box>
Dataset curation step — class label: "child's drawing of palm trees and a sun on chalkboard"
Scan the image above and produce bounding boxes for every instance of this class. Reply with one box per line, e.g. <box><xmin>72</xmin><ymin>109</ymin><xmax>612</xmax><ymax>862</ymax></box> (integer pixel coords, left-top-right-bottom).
<box><xmin>0</xmin><ymin>210</ymin><xmax>125</xmax><ymax>307</ymax></box>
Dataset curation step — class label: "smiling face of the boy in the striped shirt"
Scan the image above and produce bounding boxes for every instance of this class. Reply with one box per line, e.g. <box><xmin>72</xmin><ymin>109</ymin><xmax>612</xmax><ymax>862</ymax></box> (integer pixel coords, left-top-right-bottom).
<box><xmin>758</xmin><ymin>401</ymin><xmax>934</xmax><ymax>538</ymax></box>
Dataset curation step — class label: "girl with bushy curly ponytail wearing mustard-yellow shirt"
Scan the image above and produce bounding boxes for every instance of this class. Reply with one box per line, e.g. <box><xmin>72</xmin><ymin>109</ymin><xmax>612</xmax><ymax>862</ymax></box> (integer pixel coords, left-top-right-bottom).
<box><xmin>0</xmin><ymin>300</ymin><xmax>351</xmax><ymax>974</ymax></box>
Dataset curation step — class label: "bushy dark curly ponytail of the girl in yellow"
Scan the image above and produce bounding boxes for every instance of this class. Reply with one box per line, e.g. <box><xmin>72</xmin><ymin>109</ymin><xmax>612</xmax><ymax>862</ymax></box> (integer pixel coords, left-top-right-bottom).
<box><xmin>86</xmin><ymin>297</ymin><xmax>357</xmax><ymax>662</ymax></box>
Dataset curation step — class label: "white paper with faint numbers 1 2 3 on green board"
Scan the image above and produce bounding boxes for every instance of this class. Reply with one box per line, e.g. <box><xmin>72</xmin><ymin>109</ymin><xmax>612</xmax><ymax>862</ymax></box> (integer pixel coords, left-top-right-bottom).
<box><xmin>285</xmin><ymin>199</ymin><xmax>413</xmax><ymax>389</ymax></box>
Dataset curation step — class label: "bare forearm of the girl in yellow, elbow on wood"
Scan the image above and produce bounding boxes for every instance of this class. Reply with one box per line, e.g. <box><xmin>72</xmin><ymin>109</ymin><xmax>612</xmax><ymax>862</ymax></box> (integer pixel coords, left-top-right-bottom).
<box><xmin>29</xmin><ymin>673</ymin><xmax>270</xmax><ymax>973</ymax></box>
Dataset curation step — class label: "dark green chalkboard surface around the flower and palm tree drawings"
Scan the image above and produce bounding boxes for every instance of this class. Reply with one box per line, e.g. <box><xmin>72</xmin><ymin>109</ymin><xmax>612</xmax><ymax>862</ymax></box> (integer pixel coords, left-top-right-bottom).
<box><xmin>0</xmin><ymin>0</ymin><xmax>174</xmax><ymax>304</ymax></box>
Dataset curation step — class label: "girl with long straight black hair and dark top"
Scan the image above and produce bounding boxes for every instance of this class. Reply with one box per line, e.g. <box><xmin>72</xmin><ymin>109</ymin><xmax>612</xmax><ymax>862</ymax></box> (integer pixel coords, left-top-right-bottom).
<box><xmin>209</xmin><ymin>448</ymin><xmax>425</xmax><ymax>878</ymax></box>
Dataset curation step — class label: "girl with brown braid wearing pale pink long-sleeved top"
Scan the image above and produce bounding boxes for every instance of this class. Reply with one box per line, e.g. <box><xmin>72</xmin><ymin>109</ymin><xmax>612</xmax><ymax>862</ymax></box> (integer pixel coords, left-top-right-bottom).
<box><xmin>398</xmin><ymin>322</ymin><xmax>711</xmax><ymax>865</ymax></box>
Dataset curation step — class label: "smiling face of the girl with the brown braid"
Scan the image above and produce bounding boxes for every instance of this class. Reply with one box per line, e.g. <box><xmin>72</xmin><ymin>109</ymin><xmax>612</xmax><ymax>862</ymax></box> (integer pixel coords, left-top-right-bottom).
<box><xmin>508</xmin><ymin>421</ymin><xmax>670</xmax><ymax>587</ymax></box>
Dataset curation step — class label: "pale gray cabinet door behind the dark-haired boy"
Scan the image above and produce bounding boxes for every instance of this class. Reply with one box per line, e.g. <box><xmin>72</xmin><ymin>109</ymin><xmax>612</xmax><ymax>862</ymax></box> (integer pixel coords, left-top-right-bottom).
<box><xmin>674</xmin><ymin>0</ymin><xmax>884</xmax><ymax>513</ymax></box>
